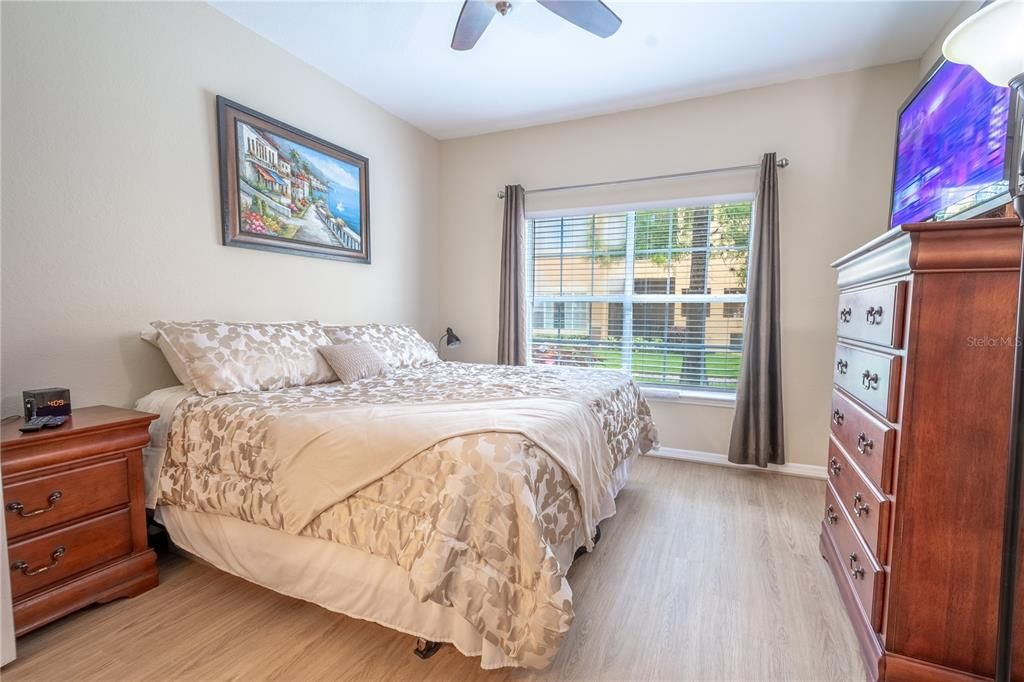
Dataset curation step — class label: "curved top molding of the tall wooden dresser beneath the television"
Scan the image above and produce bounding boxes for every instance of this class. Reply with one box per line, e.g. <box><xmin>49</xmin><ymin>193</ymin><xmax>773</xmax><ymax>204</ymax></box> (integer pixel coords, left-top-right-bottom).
<box><xmin>831</xmin><ymin>218</ymin><xmax>1021</xmax><ymax>289</ymax></box>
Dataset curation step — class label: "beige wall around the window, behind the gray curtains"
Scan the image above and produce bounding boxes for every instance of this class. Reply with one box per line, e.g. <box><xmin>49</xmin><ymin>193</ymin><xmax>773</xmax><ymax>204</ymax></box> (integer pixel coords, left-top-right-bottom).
<box><xmin>440</xmin><ymin>61</ymin><xmax>919</xmax><ymax>465</ymax></box>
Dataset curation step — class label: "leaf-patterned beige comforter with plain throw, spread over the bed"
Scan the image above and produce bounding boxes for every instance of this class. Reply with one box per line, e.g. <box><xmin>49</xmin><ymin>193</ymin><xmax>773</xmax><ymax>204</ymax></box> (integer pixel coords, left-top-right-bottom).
<box><xmin>139</xmin><ymin>363</ymin><xmax>656</xmax><ymax>668</ymax></box>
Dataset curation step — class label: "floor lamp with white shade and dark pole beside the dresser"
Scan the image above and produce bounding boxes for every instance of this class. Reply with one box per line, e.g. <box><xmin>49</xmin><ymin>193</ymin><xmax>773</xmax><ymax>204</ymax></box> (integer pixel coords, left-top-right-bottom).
<box><xmin>942</xmin><ymin>0</ymin><xmax>1024</xmax><ymax>682</ymax></box>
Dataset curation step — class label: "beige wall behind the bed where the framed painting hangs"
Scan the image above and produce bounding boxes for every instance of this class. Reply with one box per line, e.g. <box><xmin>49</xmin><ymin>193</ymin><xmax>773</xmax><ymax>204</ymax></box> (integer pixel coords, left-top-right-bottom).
<box><xmin>0</xmin><ymin>2</ymin><xmax>440</xmax><ymax>415</ymax></box>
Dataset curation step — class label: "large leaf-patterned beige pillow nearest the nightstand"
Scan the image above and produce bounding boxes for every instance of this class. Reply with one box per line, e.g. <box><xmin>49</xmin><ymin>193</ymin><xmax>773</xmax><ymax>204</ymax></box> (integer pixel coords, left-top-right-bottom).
<box><xmin>151</xmin><ymin>319</ymin><xmax>336</xmax><ymax>395</ymax></box>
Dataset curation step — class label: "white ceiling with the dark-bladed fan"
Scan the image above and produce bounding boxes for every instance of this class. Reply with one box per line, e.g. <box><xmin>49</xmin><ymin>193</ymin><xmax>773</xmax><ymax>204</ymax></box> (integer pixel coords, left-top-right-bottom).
<box><xmin>211</xmin><ymin>0</ymin><xmax>958</xmax><ymax>139</ymax></box>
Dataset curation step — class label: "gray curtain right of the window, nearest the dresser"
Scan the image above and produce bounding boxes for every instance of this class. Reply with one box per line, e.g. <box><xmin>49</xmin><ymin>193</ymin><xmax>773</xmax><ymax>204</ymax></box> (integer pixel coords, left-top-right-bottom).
<box><xmin>729</xmin><ymin>154</ymin><xmax>785</xmax><ymax>467</ymax></box>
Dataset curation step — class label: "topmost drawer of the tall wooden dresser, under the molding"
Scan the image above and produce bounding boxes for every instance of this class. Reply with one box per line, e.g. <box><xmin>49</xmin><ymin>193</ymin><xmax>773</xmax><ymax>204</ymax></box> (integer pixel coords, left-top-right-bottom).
<box><xmin>836</xmin><ymin>282</ymin><xmax>906</xmax><ymax>348</ymax></box>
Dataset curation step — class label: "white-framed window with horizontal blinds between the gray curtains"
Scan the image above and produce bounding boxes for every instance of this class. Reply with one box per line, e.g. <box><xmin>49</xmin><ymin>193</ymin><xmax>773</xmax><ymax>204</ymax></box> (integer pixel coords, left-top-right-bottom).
<box><xmin>527</xmin><ymin>200</ymin><xmax>752</xmax><ymax>392</ymax></box>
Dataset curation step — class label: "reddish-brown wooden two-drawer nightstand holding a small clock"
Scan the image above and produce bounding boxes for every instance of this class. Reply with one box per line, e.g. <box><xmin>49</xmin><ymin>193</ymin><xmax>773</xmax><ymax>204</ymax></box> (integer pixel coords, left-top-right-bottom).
<box><xmin>0</xmin><ymin>407</ymin><xmax>159</xmax><ymax>635</ymax></box>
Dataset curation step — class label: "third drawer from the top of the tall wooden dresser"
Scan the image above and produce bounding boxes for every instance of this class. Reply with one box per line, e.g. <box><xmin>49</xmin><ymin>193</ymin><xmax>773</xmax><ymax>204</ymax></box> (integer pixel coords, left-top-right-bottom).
<box><xmin>829</xmin><ymin>389</ymin><xmax>896</xmax><ymax>493</ymax></box>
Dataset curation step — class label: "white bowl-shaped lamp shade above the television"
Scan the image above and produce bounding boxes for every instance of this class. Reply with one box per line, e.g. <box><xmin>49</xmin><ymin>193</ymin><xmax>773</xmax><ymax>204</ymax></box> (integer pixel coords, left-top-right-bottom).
<box><xmin>942</xmin><ymin>0</ymin><xmax>1024</xmax><ymax>86</ymax></box>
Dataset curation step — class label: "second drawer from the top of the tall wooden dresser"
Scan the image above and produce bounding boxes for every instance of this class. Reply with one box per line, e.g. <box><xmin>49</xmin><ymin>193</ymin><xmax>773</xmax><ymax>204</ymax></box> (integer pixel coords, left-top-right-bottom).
<box><xmin>833</xmin><ymin>343</ymin><xmax>900</xmax><ymax>421</ymax></box>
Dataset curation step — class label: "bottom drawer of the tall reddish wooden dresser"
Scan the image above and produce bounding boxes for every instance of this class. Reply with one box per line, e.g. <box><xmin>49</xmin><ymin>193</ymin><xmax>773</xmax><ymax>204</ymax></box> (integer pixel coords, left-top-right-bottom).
<box><xmin>825</xmin><ymin>482</ymin><xmax>886</xmax><ymax>632</ymax></box>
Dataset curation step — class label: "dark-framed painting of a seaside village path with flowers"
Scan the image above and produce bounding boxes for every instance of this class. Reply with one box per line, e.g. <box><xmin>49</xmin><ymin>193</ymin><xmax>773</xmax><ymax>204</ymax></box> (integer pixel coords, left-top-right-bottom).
<box><xmin>217</xmin><ymin>96</ymin><xmax>370</xmax><ymax>263</ymax></box>
